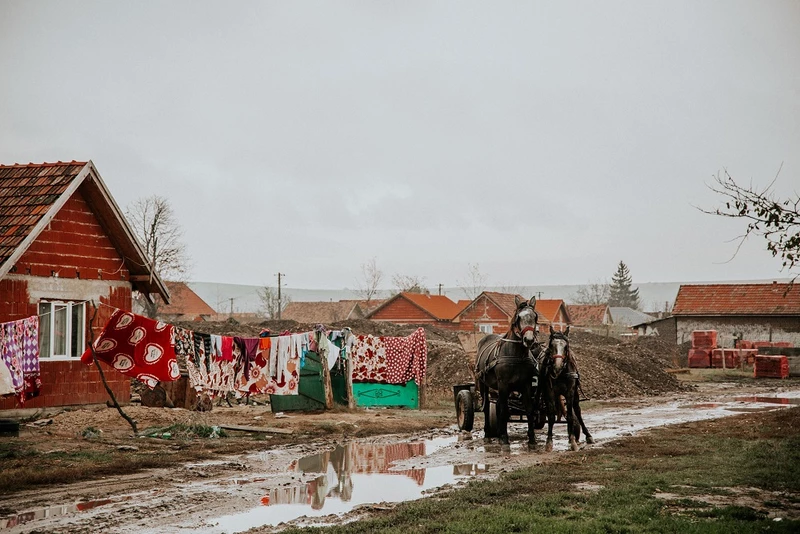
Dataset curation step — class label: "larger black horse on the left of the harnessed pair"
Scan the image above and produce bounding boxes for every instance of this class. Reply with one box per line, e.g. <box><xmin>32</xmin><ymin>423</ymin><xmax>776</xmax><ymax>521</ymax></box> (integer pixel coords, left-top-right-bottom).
<box><xmin>475</xmin><ymin>297</ymin><xmax>539</xmax><ymax>445</ymax></box>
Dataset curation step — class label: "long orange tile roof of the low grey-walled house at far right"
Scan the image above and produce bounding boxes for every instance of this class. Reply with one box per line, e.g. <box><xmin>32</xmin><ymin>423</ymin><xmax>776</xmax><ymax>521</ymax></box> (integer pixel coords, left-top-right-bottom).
<box><xmin>672</xmin><ymin>283</ymin><xmax>800</xmax><ymax>315</ymax></box>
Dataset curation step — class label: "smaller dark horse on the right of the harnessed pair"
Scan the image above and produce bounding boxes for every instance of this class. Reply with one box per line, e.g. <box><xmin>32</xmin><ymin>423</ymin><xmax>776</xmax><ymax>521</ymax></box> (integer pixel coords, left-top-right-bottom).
<box><xmin>537</xmin><ymin>325</ymin><xmax>594</xmax><ymax>451</ymax></box>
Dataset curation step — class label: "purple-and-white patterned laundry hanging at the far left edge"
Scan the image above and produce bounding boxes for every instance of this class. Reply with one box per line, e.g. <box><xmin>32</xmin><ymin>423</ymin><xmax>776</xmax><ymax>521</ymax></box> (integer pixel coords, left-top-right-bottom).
<box><xmin>0</xmin><ymin>316</ymin><xmax>42</xmax><ymax>404</ymax></box>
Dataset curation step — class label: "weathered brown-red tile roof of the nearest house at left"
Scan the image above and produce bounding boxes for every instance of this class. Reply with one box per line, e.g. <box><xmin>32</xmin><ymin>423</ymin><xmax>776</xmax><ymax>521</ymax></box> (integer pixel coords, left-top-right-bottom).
<box><xmin>0</xmin><ymin>161</ymin><xmax>86</xmax><ymax>265</ymax></box>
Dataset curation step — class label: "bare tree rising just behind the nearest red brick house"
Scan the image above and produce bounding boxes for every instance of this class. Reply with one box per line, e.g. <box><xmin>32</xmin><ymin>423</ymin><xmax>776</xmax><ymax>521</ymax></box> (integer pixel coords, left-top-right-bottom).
<box><xmin>125</xmin><ymin>195</ymin><xmax>191</xmax><ymax>317</ymax></box>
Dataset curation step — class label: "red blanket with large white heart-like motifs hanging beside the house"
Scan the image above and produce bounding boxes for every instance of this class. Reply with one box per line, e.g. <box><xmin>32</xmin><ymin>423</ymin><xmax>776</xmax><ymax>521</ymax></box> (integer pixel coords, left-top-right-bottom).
<box><xmin>81</xmin><ymin>310</ymin><xmax>181</xmax><ymax>389</ymax></box>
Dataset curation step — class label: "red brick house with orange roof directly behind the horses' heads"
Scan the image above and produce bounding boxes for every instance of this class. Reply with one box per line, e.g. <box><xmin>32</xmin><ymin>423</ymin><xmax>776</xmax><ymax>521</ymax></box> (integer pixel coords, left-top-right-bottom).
<box><xmin>456</xmin><ymin>291</ymin><xmax>570</xmax><ymax>334</ymax></box>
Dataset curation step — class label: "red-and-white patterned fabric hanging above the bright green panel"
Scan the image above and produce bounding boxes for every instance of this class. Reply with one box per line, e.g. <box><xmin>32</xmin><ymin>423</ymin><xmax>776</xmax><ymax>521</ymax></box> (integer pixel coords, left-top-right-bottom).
<box><xmin>350</xmin><ymin>328</ymin><xmax>428</xmax><ymax>385</ymax></box>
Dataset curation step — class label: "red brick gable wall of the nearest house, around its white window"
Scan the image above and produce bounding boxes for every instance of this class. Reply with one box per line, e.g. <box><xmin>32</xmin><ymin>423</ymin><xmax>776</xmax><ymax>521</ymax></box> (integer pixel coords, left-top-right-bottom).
<box><xmin>0</xmin><ymin>192</ymin><xmax>131</xmax><ymax>410</ymax></box>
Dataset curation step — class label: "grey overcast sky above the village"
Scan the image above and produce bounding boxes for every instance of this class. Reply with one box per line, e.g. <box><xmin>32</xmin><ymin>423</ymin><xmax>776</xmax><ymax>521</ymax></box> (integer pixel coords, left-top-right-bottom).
<box><xmin>0</xmin><ymin>0</ymin><xmax>800</xmax><ymax>288</ymax></box>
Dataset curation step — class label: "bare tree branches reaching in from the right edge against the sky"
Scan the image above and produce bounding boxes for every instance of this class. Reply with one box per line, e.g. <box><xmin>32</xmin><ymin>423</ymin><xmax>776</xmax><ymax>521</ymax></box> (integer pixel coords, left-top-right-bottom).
<box><xmin>700</xmin><ymin>168</ymin><xmax>800</xmax><ymax>283</ymax></box>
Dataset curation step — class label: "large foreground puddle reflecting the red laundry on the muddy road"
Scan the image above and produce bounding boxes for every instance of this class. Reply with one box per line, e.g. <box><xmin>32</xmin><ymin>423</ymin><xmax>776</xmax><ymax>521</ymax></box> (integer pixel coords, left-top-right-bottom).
<box><xmin>206</xmin><ymin>437</ymin><xmax>486</xmax><ymax>532</ymax></box>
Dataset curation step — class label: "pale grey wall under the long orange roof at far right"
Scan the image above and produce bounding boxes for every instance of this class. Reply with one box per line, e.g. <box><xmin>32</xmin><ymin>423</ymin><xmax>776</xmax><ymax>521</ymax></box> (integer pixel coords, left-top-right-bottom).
<box><xmin>676</xmin><ymin>316</ymin><xmax>800</xmax><ymax>348</ymax></box>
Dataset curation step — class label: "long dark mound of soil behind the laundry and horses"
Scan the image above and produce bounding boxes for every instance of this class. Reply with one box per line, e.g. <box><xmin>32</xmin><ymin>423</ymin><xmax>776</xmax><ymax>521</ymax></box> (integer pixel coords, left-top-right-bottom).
<box><xmin>170</xmin><ymin>319</ymin><xmax>687</xmax><ymax>399</ymax></box>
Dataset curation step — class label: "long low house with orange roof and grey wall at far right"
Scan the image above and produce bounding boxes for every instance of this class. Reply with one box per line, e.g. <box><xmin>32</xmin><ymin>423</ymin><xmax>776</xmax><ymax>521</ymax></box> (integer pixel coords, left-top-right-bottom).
<box><xmin>672</xmin><ymin>282</ymin><xmax>800</xmax><ymax>347</ymax></box>
